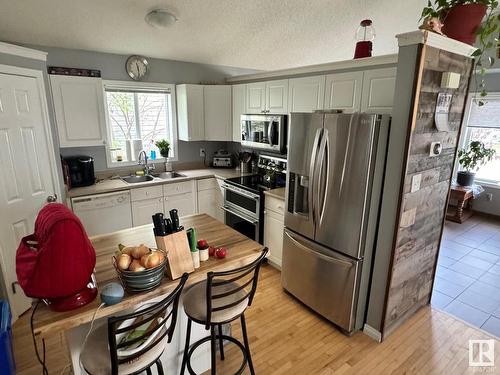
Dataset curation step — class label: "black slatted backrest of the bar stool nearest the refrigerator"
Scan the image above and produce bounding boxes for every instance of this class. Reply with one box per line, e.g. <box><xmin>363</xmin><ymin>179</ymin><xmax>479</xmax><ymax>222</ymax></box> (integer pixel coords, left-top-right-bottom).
<box><xmin>206</xmin><ymin>247</ymin><xmax>269</xmax><ymax>329</ymax></box>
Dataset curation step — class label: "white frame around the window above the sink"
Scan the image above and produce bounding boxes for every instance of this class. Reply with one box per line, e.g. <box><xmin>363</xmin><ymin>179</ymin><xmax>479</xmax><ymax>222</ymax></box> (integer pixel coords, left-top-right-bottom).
<box><xmin>102</xmin><ymin>80</ymin><xmax>179</xmax><ymax>169</ymax></box>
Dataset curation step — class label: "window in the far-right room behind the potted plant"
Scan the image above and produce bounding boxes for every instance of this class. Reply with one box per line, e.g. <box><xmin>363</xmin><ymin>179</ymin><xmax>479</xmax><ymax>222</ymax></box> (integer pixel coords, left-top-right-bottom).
<box><xmin>462</xmin><ymin>93</ymin><xmax>500</xmax><ymax>187</ymax></box>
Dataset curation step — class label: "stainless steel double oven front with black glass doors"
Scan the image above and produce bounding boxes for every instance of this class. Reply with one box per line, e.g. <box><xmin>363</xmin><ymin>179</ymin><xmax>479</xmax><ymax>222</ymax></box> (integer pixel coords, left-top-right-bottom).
<box><xmin>222</xmin><ymin>183</ymin><xmax>262</xmax><ymax>242</ymax></box>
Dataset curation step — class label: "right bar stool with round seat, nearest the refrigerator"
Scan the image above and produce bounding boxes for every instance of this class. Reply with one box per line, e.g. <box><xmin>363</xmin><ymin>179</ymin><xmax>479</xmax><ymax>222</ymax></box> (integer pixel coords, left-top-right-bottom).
<box><xmin>181</xmin><ymin>247</ymin><xmax>268</xmax><ymax>375</ymax></box>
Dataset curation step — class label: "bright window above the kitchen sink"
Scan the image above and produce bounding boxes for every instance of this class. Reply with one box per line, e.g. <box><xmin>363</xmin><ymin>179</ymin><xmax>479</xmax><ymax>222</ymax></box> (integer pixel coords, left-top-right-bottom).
<box><xmin>104</xmin><ymin>81</ymin><xmax>177</xmax><ymax>167</ymax></box>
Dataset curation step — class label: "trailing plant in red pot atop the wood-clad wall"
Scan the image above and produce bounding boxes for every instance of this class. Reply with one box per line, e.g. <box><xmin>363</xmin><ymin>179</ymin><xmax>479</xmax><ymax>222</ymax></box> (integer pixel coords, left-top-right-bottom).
<box><xmin>421</xmin><ymin>0</ymin><xmax>500</xmax><ymax>106</ymax></box>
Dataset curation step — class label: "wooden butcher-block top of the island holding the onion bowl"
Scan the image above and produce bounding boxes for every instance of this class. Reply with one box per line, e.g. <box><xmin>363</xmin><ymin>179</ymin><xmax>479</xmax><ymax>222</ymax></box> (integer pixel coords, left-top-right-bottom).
<box><xmin>34</xmin><ymin>214</ymin><xmax>263</xmax><ymax>337</ymax></box>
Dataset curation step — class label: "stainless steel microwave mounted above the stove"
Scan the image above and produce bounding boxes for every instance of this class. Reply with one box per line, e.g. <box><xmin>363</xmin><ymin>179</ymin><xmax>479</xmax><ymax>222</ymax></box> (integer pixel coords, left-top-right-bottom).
<box><xmin>241</xmin><ymin>114</ymin><xmax>286</xmax><ymax>154</ymax></box>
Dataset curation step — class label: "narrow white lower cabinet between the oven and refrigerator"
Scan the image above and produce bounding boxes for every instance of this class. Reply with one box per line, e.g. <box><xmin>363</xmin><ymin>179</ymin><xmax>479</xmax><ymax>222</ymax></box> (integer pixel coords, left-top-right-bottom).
<box><xmin>264</xmin><ymin>196</ymin><xmax>285</xmax><ymax>269</ymax></box>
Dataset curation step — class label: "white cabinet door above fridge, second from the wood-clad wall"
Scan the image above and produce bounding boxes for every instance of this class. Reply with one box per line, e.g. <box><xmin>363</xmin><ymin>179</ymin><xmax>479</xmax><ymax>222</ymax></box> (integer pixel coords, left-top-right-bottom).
<box><xmin>324</xmin><ymin>72</ymin><xmax>363</xmax><ymax>113</ymax></box>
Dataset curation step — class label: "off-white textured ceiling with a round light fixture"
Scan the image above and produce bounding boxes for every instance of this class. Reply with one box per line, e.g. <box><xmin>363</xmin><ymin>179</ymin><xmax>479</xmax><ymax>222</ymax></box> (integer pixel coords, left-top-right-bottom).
<box><xmin>0</xmin><ymin>0</ymin><xmax>426</xmax><ymax>70</ymax></box>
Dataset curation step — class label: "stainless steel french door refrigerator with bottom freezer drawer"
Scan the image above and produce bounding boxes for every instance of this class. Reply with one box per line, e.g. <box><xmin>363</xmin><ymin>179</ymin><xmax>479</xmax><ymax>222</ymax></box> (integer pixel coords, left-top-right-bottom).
<box><xmin>281</xmin><ymin>113</ymin><xmax>390</xmax><ymax>333</ymax></box>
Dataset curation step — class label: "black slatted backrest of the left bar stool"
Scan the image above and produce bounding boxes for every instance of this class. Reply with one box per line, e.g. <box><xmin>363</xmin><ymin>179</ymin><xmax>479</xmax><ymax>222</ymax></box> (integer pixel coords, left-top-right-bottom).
<box><xmin>108</xmin><ymin>273</ymin><xmax>189</xmax><ymax>375</ymax></box>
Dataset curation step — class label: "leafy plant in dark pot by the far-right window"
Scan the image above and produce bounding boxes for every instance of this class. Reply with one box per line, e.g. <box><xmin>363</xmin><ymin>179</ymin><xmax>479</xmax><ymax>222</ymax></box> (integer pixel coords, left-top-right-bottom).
<box><xmin>457</xmin><ymin>141</ymin><xmax>495</xmax><ymax>186</ymax></box>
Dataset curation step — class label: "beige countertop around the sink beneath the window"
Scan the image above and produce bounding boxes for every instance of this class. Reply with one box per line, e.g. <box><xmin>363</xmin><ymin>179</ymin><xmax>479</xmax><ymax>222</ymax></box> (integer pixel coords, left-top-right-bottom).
<box><xmin>66</xmin><ymin>168</ymin><xmax>252</xmax><ymax>198</ymax></box>
